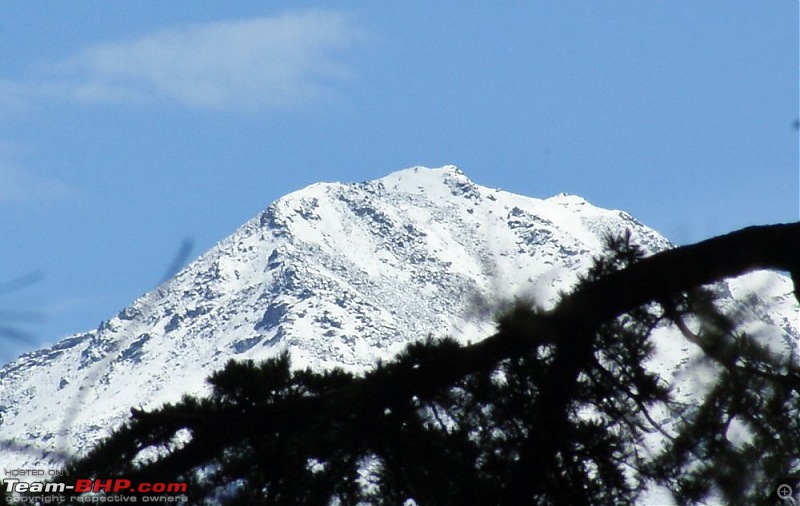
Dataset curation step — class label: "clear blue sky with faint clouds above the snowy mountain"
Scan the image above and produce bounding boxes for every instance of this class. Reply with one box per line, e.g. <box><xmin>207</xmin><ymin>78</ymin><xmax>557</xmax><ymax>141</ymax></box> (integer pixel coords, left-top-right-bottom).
<box><xmin>0</xmin><ymin>0</ymin><xmax>799</xmax><ymax>361</ymax></box>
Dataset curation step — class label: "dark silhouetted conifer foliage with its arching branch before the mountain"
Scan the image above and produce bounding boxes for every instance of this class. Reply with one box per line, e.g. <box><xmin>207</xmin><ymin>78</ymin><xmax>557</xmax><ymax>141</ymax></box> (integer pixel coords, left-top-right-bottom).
<box><xmin>53</xmin><ymin>225</ymin><xmax>800</xmax><ymax>505</ymax></box>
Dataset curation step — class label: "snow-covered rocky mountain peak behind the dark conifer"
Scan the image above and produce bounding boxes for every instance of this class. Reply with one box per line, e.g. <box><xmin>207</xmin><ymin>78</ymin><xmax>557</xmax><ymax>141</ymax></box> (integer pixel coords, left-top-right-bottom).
<box><xmin>0</xmin><ymin>166</ymin><xmax>800</xmax><ymax>469</ymax></box>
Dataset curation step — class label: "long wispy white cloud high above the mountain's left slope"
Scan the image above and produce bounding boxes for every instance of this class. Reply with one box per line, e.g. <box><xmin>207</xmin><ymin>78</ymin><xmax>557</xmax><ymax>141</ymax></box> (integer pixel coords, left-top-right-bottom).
<box><xmin>0</xmin><ymin>10</ymin><xmax>360</xmax><ymax>110</ymax></box>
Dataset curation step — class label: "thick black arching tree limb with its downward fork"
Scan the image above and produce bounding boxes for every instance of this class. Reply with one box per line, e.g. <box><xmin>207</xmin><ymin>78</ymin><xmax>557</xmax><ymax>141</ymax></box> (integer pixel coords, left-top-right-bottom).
<box><xmin>69</xmin><ymin>223</ymin><xmax>800</xmax><ymax>504</ymax></box>
